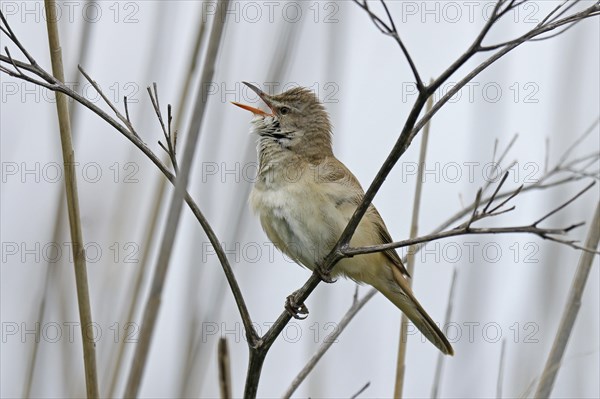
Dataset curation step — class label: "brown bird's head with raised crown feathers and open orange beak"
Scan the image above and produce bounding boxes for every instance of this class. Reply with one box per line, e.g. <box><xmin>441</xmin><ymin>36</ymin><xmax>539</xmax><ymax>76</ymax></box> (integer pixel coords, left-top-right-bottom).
<box><xmin>233</xmin><ymin>82</ymin><xmax>332</xmax><ymax>159</ymax></box>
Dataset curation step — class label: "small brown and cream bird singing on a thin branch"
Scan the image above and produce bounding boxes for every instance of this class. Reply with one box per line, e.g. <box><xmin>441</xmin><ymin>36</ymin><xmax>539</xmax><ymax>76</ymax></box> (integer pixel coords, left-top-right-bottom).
<box><xmin>234</xmin><ymin>82</ymin><xmax>454</xmax><ymax>355</ymax></box>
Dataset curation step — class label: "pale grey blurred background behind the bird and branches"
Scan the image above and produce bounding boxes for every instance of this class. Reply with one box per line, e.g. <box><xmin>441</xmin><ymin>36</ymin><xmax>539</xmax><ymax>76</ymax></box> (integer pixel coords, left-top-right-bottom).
<box><xmin>0</xmin><ymin>0</ymin><xmax>600</xmax><ymax>398</ymax></box>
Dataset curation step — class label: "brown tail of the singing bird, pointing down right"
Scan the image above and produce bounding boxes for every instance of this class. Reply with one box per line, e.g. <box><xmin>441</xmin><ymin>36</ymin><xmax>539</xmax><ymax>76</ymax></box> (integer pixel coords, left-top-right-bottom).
<box><xmin>375</xmin><ymin>270</ymin><xmax>454</xmax><ymax>355</ymax></box>
